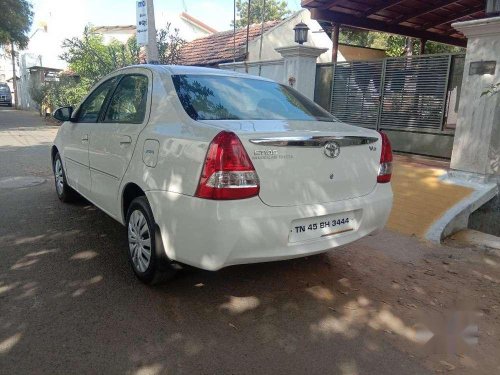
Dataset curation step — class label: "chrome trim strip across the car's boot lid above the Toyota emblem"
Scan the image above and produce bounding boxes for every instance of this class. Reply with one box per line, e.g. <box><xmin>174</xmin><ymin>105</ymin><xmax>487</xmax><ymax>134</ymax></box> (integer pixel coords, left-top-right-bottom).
<box><xmin>250</xmin><ymin>135</ymin><xmax>378</xmax><ymax>147</ymax></box>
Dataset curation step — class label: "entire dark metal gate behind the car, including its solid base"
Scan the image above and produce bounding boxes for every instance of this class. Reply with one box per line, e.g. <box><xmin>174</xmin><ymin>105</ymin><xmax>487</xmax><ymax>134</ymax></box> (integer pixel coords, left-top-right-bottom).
<box><xmin>322</xmin><ymin>54</ymin><xmax>465</xmax><ymax>158</ymax></box>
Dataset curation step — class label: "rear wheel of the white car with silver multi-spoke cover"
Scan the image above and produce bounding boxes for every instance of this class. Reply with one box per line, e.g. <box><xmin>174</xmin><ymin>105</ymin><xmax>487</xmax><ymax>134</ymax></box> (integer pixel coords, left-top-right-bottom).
<box><xmin>126</xmin><ymin>197</ymin><xmax>177</xmax><ymax>285</ymax></box>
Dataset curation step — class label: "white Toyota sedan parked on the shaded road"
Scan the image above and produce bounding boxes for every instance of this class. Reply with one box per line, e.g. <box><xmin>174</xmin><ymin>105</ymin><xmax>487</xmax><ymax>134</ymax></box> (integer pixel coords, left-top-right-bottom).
<box><xmin>52</xmin><ymin>65</ymin><xmax>392</xmax><ymax>283</ymax></box>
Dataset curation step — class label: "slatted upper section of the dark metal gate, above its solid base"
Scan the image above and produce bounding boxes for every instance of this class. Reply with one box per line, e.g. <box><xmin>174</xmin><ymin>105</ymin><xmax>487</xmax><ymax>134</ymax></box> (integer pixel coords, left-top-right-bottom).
<box><xmin>330</xmin><ymin>54</ymin><xmax>464</xmax><ymax>131</ymax></box>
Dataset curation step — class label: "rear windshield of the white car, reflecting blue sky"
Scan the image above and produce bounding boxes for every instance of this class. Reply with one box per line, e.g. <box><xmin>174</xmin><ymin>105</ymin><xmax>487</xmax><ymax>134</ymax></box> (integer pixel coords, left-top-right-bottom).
<box><xmin>172</xmin><ymin>75</ymin><xmax>335</xmax><ymax>121</ymax></box>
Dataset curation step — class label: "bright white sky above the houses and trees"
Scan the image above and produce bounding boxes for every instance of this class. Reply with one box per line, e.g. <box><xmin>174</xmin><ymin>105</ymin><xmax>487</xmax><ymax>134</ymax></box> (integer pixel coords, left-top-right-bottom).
<box><xmin>30</xmin><ymin>0</ymin><xmax>300</xmax><ymax>68</ymax></box>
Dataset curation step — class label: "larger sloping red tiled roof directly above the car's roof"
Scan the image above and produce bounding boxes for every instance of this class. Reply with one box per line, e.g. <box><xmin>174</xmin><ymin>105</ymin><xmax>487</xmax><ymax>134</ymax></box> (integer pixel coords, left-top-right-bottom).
<box><xmin>179</xmin><ymin>21</ymin><xmax>281</xmax><ymax>66</ymax></box>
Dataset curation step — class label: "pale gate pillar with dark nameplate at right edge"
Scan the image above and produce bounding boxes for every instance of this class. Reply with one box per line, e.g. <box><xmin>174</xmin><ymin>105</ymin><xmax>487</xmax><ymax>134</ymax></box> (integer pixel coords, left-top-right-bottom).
<box><xmin>451</xmin><ymin>17</ymin><xmax>500</xmax><ymax>179</ymax></box>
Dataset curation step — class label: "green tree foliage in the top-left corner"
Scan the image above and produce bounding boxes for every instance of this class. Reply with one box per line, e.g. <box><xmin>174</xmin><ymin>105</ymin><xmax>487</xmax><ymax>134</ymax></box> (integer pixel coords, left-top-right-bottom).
<box><xmin>0</xmin><ymin>0</ymin><xmax>33</xmax><ymax>49</ymax></box>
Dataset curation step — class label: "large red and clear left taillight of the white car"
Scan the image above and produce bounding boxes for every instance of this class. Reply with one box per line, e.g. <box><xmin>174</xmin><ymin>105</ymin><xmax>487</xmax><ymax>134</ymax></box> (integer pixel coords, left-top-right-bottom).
<box><xmin>196</xmin><ymin>131</ymin><xmax>260</xmax><ymax>200</ymax></box>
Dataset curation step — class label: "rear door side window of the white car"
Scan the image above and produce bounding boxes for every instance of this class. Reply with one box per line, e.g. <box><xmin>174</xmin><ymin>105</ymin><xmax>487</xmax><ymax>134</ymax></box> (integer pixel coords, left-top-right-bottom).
<box><xmin>104</xmin><ymin>75</ymin><xmax>148</xmax><ymax>124</ymax></box>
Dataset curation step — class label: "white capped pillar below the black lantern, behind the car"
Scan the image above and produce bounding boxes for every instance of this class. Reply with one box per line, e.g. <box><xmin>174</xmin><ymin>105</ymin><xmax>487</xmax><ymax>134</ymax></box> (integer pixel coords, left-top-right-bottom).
<box><xmin>276</xmin><ymin>44</ymin><xmax>328</xmax><ymax>100</ymax></box>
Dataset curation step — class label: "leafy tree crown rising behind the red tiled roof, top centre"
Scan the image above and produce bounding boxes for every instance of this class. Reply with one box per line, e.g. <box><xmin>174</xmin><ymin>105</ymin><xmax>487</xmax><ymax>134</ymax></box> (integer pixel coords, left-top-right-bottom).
<box><xmin>231</xmin><ymin>0</ymin><xmax>291</xmax><ymax>28</ymax></box>
